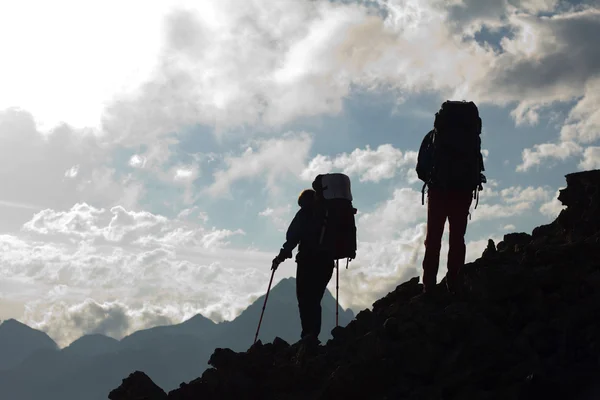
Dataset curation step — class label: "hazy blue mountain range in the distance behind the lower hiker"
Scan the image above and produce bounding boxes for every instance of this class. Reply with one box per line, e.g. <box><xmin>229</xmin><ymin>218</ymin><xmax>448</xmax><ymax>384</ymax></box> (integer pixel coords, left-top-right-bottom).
<box><xmin>0</xmin><ymin>278</ymin><xmax>354</xmax><ymax>400</ymax></box>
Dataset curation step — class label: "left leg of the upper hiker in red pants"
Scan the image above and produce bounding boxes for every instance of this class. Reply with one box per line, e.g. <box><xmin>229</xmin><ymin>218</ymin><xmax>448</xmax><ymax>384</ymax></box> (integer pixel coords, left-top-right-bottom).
<box><xmin>423</xmin><ymin>189</ymin><xmax>446</xmax><ymax>291</ymax></box>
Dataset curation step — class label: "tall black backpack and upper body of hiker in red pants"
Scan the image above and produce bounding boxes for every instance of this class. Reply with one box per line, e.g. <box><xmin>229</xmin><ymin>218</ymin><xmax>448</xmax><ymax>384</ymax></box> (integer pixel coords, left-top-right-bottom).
<box><xmin>417</xmin><ymin>100</ymin><xmax>485</xmax><ymax>206</ymax></box>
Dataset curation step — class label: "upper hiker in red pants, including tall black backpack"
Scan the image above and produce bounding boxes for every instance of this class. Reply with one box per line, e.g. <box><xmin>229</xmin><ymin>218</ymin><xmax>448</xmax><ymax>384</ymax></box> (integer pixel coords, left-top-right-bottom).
<box><xmin>417</xmin><ymin>101</ymin><xmax>486</xmax><ymax>293</ymax></box>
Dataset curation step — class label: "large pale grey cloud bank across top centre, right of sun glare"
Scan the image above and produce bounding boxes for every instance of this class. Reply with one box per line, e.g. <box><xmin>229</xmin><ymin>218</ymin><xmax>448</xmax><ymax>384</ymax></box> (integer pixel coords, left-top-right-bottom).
<box><xmin>103</xmin><ymin>0</ymin><xmax>493</xmax><ymax>144</ymax></box>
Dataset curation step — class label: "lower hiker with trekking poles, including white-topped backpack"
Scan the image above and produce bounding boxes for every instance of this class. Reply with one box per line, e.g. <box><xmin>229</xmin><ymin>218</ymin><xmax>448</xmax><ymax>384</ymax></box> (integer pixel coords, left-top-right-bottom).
<box><xmin>273</xmin><ymin>174</ymin><xmax>356</xmax><ymax>342</ymax></box>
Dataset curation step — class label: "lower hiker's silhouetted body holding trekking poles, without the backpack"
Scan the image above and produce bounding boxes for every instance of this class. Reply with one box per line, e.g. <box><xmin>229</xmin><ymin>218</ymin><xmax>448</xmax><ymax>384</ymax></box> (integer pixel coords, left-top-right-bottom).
<box><xmin>273</xmin><ymin>189</ymin><xmax>335</xmax><ymax>341</ymax></box>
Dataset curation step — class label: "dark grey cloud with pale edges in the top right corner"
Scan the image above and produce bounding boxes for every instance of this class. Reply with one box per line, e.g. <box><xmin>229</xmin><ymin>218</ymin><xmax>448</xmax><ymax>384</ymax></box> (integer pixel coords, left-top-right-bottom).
<box><xmin>478</xmin><ymin>7</ymin><xmax>600</xmax><ymax>109</ymax></box>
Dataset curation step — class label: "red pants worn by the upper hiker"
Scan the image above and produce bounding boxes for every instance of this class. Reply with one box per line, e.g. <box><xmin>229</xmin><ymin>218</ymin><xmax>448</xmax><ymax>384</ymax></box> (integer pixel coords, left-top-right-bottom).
<box><xmin>423</xmin><ymin>188</ymin><xmax>473</xmax><ymax>290</ymax></box>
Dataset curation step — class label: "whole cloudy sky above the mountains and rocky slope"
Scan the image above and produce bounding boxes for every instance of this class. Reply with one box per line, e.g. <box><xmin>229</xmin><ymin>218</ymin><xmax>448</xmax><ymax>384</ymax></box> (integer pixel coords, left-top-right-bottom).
<box><xmin>0</xmin><ymin>0</ymin><xmax>600</xmax><ymax>346</ymax></box>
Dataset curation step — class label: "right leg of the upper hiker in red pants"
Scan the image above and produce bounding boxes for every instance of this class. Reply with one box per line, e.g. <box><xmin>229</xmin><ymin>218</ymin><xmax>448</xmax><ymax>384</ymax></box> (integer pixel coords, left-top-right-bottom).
<box><xmin>446</xmin><ymin>191</ymin><xmax>473</xmax><ymax>283</ymax></box>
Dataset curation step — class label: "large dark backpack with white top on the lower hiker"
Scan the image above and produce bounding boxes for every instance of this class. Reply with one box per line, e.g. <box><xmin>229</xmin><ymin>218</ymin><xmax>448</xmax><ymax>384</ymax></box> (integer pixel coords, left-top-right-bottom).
<box><xmin>312</xmin><ymin>173</ymin><xmax>357</xmax><ymax>260</ymax></box>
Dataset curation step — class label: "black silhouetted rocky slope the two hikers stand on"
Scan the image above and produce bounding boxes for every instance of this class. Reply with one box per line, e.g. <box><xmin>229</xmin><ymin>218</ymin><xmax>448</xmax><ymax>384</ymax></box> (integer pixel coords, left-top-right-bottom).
<box><xmin>109</xmin><ymin>170</ymin><xmax>600</xmax><ymax>400</ymax></box>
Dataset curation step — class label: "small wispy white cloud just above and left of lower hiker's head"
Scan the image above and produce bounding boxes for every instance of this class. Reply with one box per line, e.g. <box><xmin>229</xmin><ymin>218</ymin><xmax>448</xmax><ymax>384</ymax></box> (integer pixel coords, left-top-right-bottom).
<box><xmin>208</xmin><ymin>133</ymin><xmax>312</xmax><ymax>196</ymax></box>
